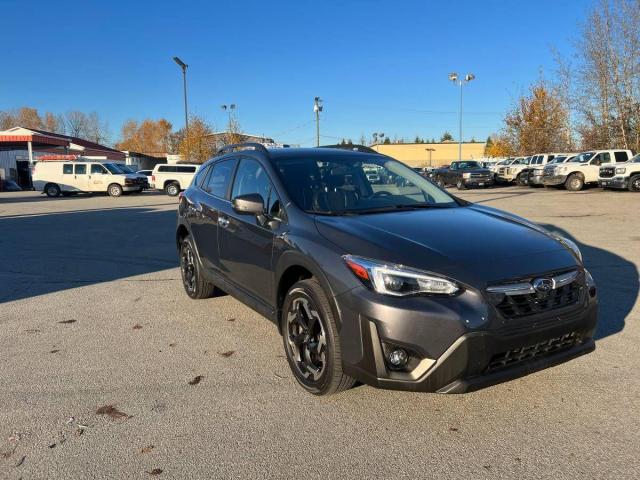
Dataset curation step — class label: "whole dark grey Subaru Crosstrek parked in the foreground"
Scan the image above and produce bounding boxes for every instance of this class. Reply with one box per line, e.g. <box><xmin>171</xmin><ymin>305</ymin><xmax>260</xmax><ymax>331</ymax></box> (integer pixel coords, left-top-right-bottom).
<box><xmin>176</xmin><ymin>144</ymin><xmax>597</xmax><ymax>395</ymax></box>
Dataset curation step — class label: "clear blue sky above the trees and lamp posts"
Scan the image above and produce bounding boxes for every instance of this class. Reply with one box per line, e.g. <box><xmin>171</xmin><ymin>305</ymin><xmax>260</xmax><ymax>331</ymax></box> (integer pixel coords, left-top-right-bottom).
<box><xmin>0</xmin><ymin>0</ymin><xmax>591</xmax><ymax>145</ymax></box>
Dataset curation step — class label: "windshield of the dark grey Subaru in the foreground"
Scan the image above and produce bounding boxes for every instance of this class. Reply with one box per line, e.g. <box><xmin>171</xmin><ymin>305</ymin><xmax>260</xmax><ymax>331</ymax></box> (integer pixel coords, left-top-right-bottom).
<box><xmin>273</xmin><ymin>155</ymin><xmax>459</xmax><ymax>215</ymax></box>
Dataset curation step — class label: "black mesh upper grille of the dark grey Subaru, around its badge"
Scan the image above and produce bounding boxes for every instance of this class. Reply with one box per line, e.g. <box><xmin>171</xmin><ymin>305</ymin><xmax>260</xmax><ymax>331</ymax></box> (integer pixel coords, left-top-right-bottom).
<box><xmin>496</xmin><ymin>281</ymin><xmax>582</xmax><ymax>318</ymax></box>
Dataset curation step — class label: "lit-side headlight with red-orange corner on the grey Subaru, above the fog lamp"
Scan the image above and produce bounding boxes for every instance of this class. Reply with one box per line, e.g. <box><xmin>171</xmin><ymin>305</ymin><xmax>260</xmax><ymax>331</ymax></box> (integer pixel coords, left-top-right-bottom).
<box><xmin>343</xmin><ymin>255</ymin><xmax>460</xmax><ymax>297</ymax></box>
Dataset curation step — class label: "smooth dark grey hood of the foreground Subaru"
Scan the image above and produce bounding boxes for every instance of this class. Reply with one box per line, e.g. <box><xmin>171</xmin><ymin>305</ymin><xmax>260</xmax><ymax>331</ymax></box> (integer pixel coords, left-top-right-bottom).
<box><xmin>316</xmin><ymin>205</ymin><xmax>578</xmax><ymax>288</ymax></box>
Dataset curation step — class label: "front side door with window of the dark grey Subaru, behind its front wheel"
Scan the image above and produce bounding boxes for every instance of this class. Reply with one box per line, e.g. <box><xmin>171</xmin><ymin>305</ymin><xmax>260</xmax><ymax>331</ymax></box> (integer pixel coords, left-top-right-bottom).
<box><xmin>218</xmin><ymin>158</ymin><xmax>283</xmax><ymax>305</ymax></box>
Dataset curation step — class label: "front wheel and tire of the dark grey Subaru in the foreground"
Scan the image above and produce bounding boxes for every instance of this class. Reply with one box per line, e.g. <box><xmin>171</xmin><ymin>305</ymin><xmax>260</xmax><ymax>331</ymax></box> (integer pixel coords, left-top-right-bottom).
<box><xmin>280</xmin><ymin>278</ymin><xmax>355</xmax><ymax>395</ymax></box>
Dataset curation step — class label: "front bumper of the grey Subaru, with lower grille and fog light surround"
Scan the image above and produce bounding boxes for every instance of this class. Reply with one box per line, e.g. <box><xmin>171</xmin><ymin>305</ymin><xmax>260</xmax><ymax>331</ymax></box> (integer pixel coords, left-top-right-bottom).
<box><xmin>336</xmin><ymin>278</ymin><xmax>597</xmax><ymax>393</ymax></box>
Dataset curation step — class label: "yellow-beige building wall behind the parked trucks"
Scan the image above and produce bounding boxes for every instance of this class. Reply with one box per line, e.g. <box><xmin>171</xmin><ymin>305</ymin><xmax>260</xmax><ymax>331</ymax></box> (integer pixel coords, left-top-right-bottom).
<box><xmin>371</xmin><ymin>142</ymin><xmax>486</xmax><ymax>167</ymax></box>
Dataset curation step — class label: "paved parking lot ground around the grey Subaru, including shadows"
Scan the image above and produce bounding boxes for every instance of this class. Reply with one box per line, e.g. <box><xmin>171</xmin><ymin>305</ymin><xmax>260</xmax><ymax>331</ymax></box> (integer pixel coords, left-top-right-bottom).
<box><xmin>0</xmin><ymin>187</ymin><xmax>640</xmax><ymax>479</ymax></box>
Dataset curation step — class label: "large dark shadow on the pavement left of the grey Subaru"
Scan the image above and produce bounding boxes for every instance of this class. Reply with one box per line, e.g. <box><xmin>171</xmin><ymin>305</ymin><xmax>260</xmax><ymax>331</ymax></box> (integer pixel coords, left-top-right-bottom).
<box><xmin>0</xmin><ymin>207</ymin><xmax>178</xmax><ymax>303</ymax></box>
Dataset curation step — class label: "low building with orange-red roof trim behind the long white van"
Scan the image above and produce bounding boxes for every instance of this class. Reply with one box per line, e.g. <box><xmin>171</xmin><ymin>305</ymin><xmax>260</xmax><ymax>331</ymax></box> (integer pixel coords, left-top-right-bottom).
<box><xmin>0</xmin><ymin>127</ymin><xmax>126</xmax><ymax>188</ymax></box>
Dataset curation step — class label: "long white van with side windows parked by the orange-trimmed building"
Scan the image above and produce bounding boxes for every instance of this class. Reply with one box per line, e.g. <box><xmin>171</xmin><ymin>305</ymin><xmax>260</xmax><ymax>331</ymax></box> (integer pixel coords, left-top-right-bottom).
<box><xmin>31</xmin><ymin>160</ymin><xmax>143</xmax><ymax>197</ymax></box>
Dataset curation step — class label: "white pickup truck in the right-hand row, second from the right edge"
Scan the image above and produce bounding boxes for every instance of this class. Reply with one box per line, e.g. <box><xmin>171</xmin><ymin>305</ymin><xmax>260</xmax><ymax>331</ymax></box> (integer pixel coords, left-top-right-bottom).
<box><xmin>542</xmin><ymin>150</ymin><xmax>633</xmax><ymax>192</ymax></box>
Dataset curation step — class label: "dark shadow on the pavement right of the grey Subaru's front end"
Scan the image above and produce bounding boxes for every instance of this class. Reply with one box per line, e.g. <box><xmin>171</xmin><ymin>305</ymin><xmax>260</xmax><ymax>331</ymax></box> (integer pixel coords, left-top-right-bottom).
<box><xmin>540</xmin><ymin>223</ymin><xmax>640</xmax><ymax>340</ymax></box>
